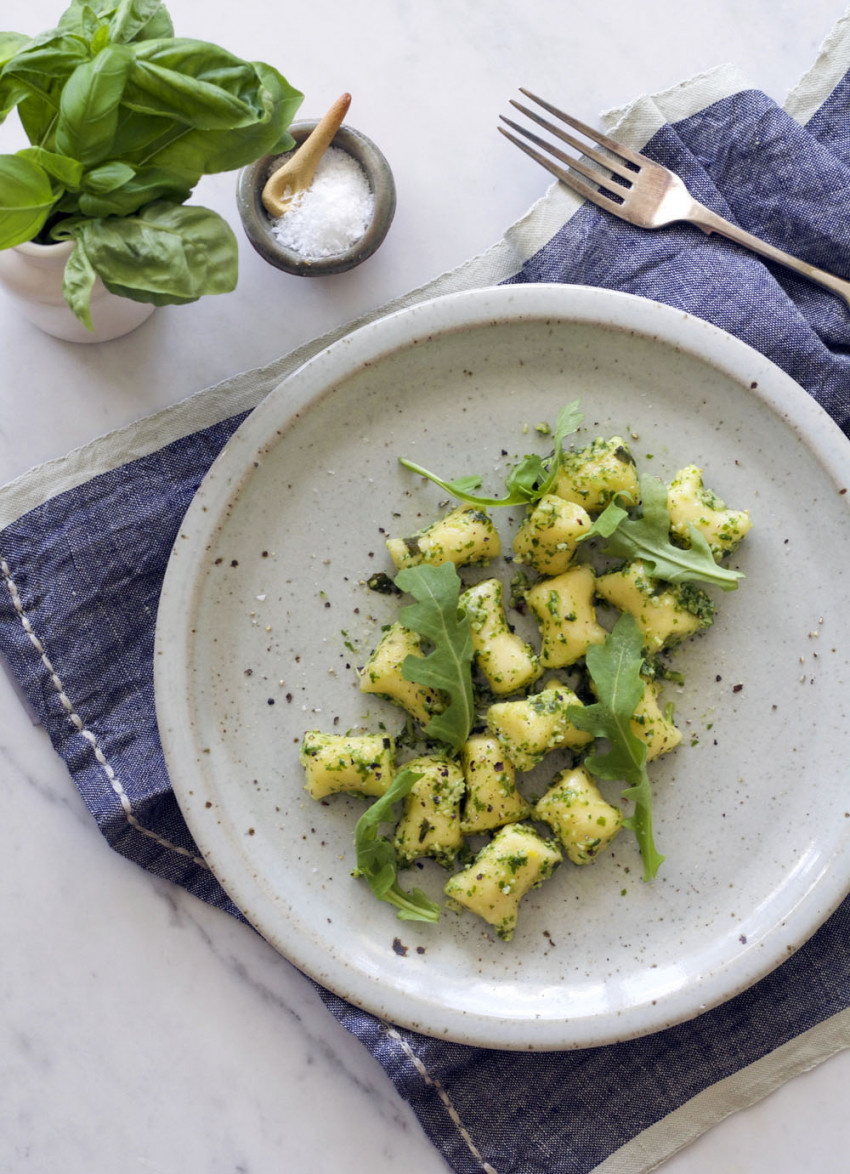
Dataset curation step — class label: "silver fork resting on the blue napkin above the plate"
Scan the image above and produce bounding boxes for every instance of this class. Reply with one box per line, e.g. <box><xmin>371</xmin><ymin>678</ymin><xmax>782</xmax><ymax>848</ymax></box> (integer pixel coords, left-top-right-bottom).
<box><xmin>499</xmin><ymin>87</ymin><xmax>850</xmax><ymax>305</ymax></box>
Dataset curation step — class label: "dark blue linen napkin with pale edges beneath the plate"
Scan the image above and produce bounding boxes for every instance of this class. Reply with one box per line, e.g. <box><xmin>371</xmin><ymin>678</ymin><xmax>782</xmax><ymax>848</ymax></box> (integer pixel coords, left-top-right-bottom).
<box><xmin>0</xmin><ymin>18</ymin><xmax>850</xmax><ymax>1174</ymax></box>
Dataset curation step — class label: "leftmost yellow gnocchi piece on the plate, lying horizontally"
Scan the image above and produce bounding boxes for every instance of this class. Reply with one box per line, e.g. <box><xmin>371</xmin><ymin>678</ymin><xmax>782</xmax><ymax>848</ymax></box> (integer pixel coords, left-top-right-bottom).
<box><xmin>299</xmin><ymin>730</ymin><xmax>396</xmax><ymax>799</ymax></box>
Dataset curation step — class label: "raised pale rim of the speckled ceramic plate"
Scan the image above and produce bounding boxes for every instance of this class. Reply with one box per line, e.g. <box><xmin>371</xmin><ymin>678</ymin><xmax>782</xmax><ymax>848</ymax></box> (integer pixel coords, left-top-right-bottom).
<box><xmin>154</xmin><ymin>284</ymin><xmax>850</xmax><ymax>1051</ymax></box>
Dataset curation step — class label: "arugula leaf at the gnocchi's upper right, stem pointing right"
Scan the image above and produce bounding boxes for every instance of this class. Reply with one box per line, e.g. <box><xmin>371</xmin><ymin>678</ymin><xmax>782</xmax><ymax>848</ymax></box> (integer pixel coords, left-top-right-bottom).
<box><xmin>582</xmin><ymin>477</ymin><xmax>743</xmax><ymax>591</ymax></box>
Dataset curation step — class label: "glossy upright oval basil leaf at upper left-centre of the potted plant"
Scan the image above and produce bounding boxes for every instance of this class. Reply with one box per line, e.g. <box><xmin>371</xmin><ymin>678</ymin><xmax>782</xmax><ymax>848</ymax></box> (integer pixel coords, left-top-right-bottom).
<box><xmin>56</xmin><ymin>45</ymin><xmax>133</xmax><ymax>163</ymax></box>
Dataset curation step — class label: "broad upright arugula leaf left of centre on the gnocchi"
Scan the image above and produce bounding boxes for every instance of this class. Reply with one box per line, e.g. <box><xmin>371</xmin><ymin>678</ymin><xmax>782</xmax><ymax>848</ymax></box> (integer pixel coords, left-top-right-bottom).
<box><xmin>396</xmin><ymin>562</ymin><xmax>474</xmax><ymax>753</ymax></box>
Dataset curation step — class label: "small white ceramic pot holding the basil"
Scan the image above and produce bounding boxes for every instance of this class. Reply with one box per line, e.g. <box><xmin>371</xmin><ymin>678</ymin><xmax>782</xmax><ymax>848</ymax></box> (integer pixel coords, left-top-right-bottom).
<box><xmin>0</xmin><ymin>241</ymin><xmax>156</xmax><ymax>343</ymax></box>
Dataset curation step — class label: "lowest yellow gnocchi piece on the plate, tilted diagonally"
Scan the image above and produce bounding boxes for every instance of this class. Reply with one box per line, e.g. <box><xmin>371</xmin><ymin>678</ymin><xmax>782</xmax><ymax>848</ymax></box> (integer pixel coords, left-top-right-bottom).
<box><xmin>444</xmin><ymin>823</ymin><xmax>562</xmax><ymax>942</ymax></box>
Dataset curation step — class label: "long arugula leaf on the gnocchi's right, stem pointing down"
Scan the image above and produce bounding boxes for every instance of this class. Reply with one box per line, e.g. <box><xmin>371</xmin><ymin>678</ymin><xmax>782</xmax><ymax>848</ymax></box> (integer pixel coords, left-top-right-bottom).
<box><xmin>567</xmin><ymin>613</ymin><xmax>665</xmax><ymax>881</ymax></box>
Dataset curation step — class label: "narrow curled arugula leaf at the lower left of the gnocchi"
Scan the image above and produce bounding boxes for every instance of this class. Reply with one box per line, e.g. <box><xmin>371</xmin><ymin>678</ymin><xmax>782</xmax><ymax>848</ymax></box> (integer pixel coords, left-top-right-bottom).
<box><xmin>351</xmin><ymin>768</ymin><xmax>440</xmax><ymax>922</ymax></box>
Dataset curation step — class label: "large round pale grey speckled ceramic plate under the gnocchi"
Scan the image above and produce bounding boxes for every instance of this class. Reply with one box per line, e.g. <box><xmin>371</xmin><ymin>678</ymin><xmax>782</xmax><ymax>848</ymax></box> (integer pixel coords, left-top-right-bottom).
<box><xmin>156</xmin><ymin>286</ymin><xmax>850</xmax><ymax>1048</ymax></box>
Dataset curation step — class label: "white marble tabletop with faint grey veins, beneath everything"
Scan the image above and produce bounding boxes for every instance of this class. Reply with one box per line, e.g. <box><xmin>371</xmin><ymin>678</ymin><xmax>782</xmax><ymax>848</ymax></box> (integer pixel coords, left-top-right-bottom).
<box><xmin>0</xmin><ymin>0</ymin><xmax>850</xmax><ymax>1174</ymax></box>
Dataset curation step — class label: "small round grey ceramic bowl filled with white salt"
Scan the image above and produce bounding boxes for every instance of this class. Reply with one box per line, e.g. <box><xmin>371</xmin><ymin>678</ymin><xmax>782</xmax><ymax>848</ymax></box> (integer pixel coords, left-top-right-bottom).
<box><xmin>237</xmin><ymin>122</ymin><xmax>396</xmax><ymax>277</ymax></box>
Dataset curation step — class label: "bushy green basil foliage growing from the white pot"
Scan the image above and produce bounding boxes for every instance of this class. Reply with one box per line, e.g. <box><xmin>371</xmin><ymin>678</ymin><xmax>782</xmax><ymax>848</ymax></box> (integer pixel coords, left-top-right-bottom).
<box><xmin>0</xmin><ymin>0</ymin><xmax>303</xmax><ymax>337</ymax></box>
